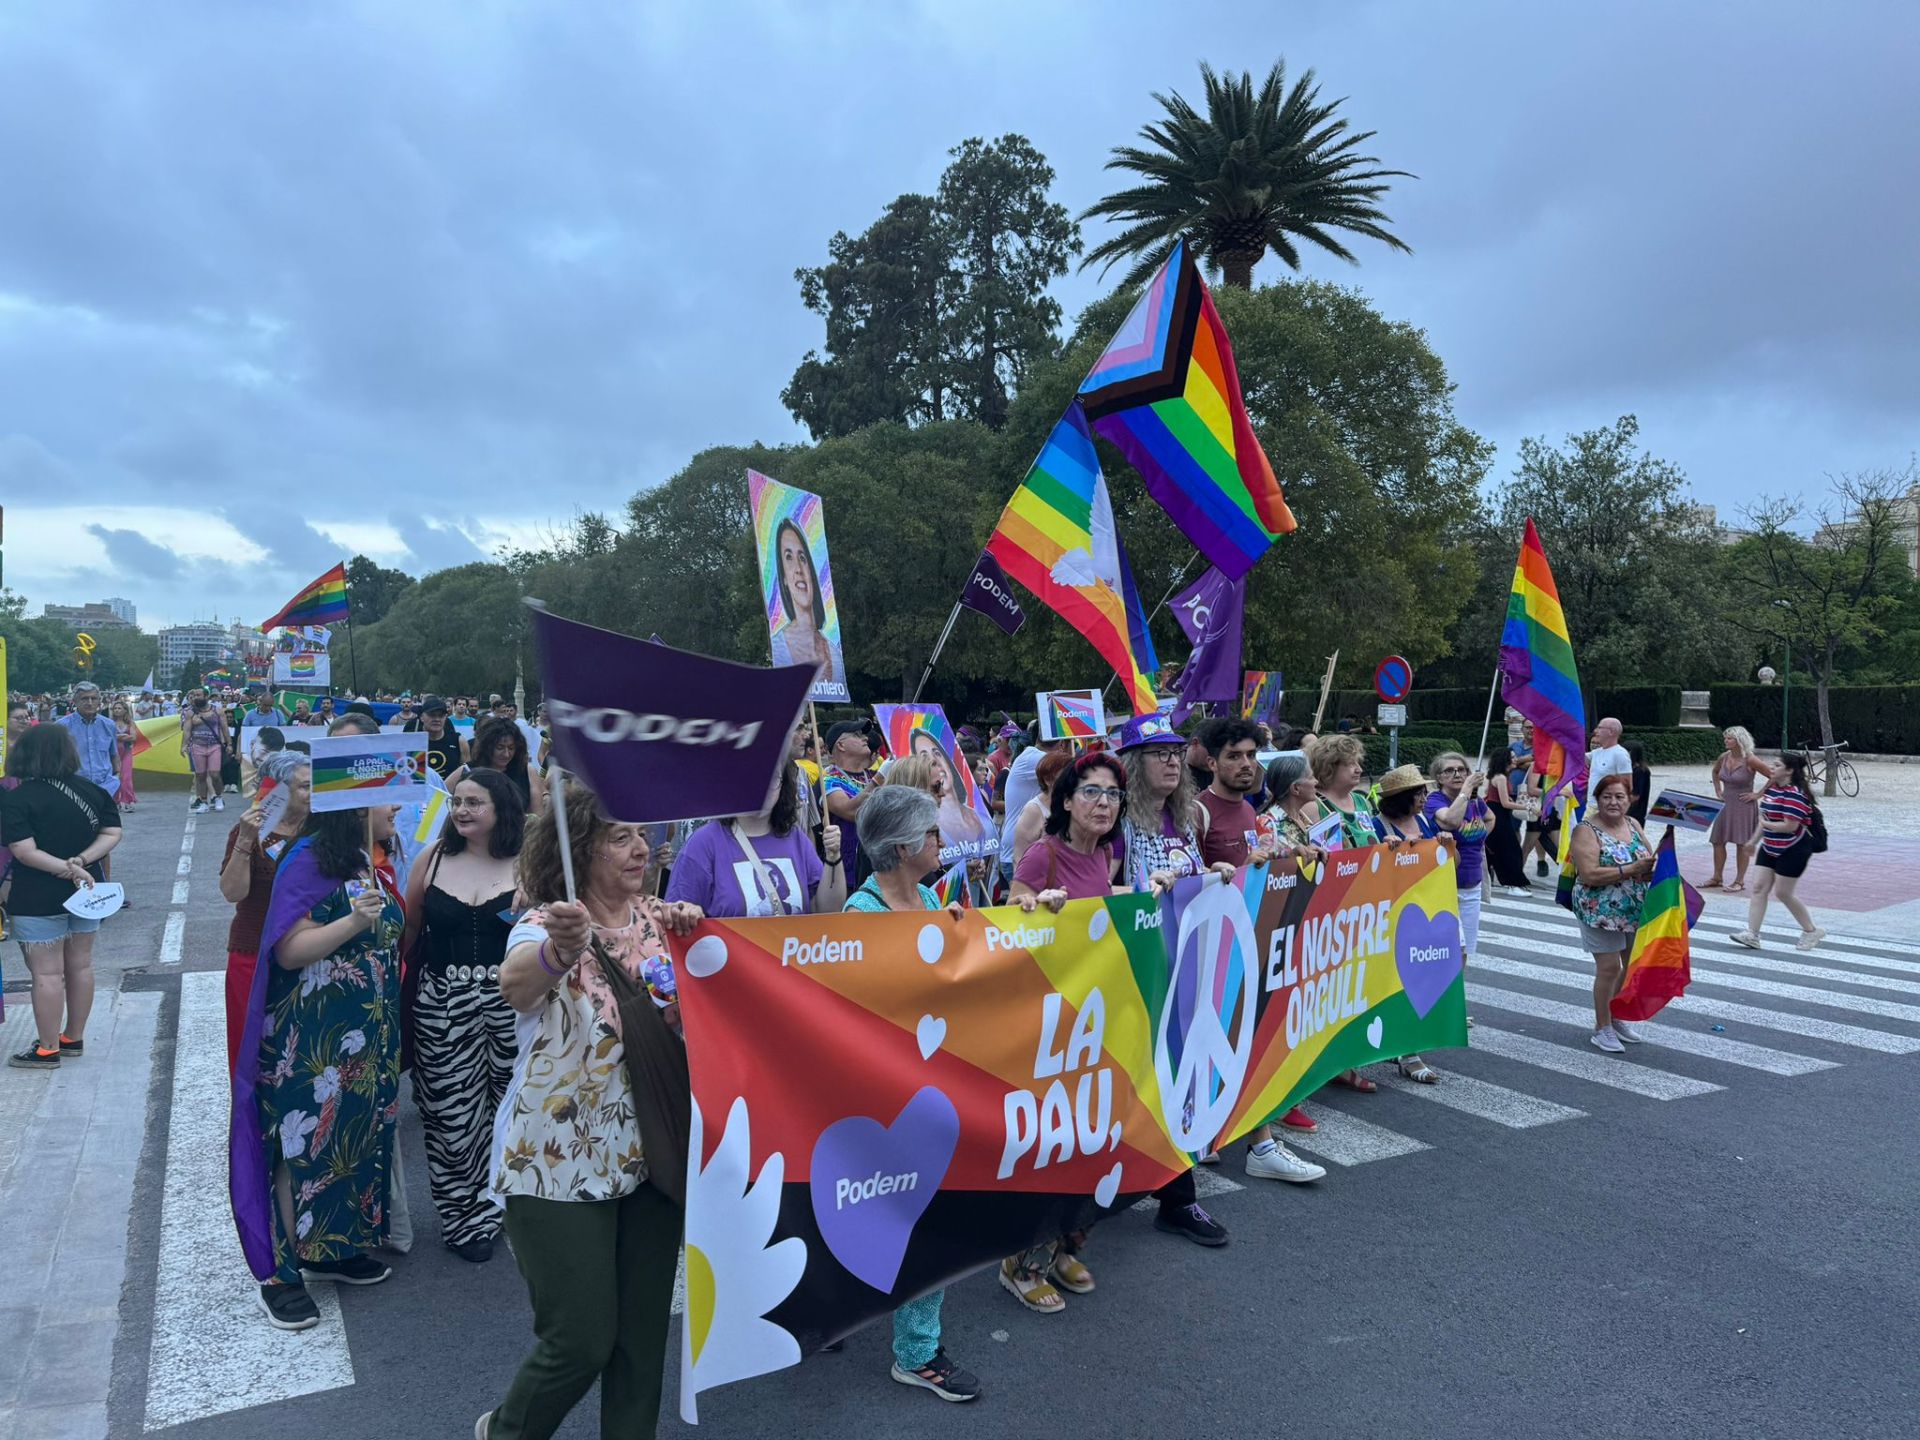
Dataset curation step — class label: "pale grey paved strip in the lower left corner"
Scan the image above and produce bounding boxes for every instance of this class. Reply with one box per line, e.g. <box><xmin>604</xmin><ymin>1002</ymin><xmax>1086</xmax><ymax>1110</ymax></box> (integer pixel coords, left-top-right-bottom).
<box><xmin>0</xmin><ymin>989</ymin><xmax>163</xmax><ymax>1440</ymax></box>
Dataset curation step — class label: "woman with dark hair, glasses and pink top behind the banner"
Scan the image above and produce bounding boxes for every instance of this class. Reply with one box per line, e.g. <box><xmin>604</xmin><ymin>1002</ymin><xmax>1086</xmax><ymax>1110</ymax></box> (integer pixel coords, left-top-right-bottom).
<box><xmin>1000</xmin><ymin>751</ymin><xmax>1127</xmax><ymax>1315</ymax></box>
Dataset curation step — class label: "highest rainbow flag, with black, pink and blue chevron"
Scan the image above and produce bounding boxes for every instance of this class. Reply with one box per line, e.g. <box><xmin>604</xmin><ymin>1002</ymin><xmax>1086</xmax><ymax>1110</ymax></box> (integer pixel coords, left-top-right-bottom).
<box><xmin>1079</xmin><ymin>240</ymin><xmax>1294</xmax><ymax>580</ymax></box>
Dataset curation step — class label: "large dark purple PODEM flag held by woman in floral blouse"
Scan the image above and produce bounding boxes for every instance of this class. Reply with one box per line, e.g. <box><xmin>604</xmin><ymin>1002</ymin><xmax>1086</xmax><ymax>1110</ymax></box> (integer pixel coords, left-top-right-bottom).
<box><xmin>528</xmin><ymin>601</ymin><xmax>814</xmax><ymax>824</ymax></box>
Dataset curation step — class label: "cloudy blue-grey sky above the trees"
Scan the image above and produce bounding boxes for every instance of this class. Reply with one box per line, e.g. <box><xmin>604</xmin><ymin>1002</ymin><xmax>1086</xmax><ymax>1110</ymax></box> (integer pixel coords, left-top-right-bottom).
<box><xmin>0</xmin><ymin>0</ymin><xmax>1920</xmax><ymax>628</ymax></box>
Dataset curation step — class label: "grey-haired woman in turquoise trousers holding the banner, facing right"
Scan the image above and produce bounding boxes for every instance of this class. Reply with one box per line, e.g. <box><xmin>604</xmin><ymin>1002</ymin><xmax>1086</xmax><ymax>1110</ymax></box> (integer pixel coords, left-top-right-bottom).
<box><xmin>845</xmin><ymin>785</ymin><xmax>979</xmax><ymax>1400</ymax></box>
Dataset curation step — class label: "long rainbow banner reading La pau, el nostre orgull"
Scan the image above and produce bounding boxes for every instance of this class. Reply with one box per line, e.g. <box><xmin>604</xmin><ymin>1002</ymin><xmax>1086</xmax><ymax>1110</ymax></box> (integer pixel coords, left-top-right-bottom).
<box><xmin>670</xmin><ymin>841</ymin><xmax>1467</xmax><ymax>1421</ymax></box>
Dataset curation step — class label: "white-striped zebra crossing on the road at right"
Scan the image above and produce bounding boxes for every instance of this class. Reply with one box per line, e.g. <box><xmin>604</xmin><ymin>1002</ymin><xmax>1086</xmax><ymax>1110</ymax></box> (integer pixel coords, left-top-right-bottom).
<box><xmin>1228</xmin><ymin>893</ymin><xmax>1920</xmax><ymax>1194</ymax></box>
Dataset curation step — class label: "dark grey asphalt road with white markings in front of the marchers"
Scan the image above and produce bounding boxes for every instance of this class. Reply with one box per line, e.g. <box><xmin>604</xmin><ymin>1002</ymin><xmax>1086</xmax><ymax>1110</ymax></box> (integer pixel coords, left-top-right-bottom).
<box><xmin>78</xmin><ymin>795</ymin><xmax>1920</xmax><ymax>1440</ymax></box>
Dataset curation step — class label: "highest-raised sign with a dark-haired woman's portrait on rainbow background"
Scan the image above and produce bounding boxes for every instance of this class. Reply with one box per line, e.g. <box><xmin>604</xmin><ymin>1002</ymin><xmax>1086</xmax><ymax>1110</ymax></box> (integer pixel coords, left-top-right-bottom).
<box><xmin>747</xmin><ymin>470</ymin><xmax>851</xmax><ymax>701</ymax></box>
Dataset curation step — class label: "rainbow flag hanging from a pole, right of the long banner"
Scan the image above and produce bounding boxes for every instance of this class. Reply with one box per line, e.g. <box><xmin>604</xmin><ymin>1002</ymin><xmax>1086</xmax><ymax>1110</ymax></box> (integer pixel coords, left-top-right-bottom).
<box><xmin>1500</xmin><ymin>516</ymin><xmax>1586</xmax><ymax>808</ymax></box>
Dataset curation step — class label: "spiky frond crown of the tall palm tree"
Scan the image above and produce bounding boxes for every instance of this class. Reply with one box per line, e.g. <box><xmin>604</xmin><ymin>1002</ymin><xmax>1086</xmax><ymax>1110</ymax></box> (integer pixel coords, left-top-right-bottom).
<box><xmin>1081</xmin><ymin>61</ymin><xmax>1413</xmax><ymax>290</ymax></box>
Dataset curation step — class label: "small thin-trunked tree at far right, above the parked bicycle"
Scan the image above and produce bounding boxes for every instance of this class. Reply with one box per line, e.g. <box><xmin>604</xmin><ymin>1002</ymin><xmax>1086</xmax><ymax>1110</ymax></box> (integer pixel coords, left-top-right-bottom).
<box><xmin>1726</xmin><ymin>470</ymin><xmax>1914</xmax><ymax>748</ymax></box>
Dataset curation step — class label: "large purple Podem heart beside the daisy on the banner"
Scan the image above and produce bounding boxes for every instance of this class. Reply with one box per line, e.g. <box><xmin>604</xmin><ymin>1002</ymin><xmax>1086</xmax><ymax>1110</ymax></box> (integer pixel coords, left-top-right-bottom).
<box><xmin>808</xmin><ymin>1085</ymin><xmax>960</xmax><ymax>1294</ymax></box>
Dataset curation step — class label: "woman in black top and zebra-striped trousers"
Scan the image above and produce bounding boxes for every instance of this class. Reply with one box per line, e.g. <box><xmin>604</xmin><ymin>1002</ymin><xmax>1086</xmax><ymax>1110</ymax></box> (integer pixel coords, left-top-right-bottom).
<box><xmin>401</xmin><ymin>770</ymin><xmax>526</xmax><ymax>1265</ymax></box>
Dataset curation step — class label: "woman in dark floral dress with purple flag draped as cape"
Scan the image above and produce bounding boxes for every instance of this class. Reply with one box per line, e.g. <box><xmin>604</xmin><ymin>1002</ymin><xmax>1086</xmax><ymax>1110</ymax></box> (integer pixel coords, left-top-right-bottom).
<box><xmin>230</xmin><ymin>806</ymin><xmax>405</xmax><ymax>1331</ymax></box>
